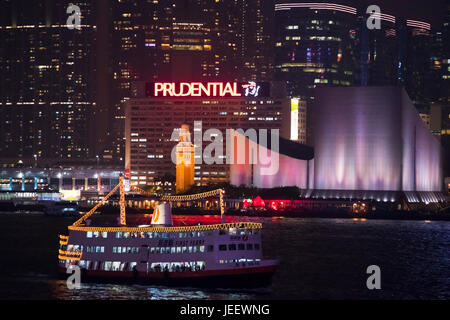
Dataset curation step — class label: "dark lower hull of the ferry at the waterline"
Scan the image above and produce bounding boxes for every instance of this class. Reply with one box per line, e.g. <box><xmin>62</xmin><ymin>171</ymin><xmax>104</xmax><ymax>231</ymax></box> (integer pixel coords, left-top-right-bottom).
<box><xmin>58</xmin><ymin>266</ymin><xmax>276</xmax><ymax>288</ymax></box>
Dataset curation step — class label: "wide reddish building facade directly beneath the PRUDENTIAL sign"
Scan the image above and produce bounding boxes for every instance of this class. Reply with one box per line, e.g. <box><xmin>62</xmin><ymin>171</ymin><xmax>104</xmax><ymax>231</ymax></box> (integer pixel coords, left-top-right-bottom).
<box><xmin>125</xmin><ymin>83</ymin><xmax>290</xmax><ymax>186</ymax></box>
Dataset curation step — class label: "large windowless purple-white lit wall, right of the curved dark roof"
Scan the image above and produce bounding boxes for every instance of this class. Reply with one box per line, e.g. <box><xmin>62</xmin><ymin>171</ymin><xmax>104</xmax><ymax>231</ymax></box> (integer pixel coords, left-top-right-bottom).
<box><xmin>313</xmin><ymin>87</ymin><xmax>442</xmax><ymax>191</ymax></box>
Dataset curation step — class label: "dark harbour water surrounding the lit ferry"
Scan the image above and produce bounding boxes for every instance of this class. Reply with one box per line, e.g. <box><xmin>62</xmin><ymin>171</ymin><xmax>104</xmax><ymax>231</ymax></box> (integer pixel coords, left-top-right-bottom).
<box><xmin>0</xmin><ymin>213</ymin><xmax>450</xmax><ymax>299</ymax></box>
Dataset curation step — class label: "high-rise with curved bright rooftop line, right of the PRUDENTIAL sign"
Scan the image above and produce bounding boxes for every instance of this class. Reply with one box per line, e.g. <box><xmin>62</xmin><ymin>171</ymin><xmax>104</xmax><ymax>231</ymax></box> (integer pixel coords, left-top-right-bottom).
<box><xmin>275</xmin><ymin>2</ymin><xmax>359</xmax><ymax>102</ymax></box>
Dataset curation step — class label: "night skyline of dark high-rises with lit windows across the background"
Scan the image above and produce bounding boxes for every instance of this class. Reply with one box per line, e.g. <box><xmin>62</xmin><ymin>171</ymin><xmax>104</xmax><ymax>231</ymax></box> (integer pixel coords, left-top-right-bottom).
<box><xmin>0</xmin><ymin>0</ymin><xmax>448</xmax><ymax>182</ymax></box>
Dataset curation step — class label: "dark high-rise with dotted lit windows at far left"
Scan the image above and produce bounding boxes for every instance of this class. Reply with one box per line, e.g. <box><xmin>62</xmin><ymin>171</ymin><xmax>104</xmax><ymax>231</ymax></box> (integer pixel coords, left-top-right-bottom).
<box><xmin>0</xmin><ymin>0</ymin><xmax>102</xmax><ymax>159</ymax></box>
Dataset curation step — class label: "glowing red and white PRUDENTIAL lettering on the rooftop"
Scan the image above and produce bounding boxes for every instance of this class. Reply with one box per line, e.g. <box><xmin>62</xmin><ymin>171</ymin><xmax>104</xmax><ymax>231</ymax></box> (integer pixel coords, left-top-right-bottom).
<box><xmin>153</xmin><ymin>82</ymin><xmax>241</xmax><ymax>97</ymax></box>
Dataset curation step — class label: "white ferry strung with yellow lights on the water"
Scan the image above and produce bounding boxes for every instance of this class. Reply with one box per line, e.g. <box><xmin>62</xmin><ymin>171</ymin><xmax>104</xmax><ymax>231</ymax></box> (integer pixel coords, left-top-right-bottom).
<box><xmin>58</xmin><ymin>177</ymin><xmax>278</xmax><ymax>288</ymax></box>
